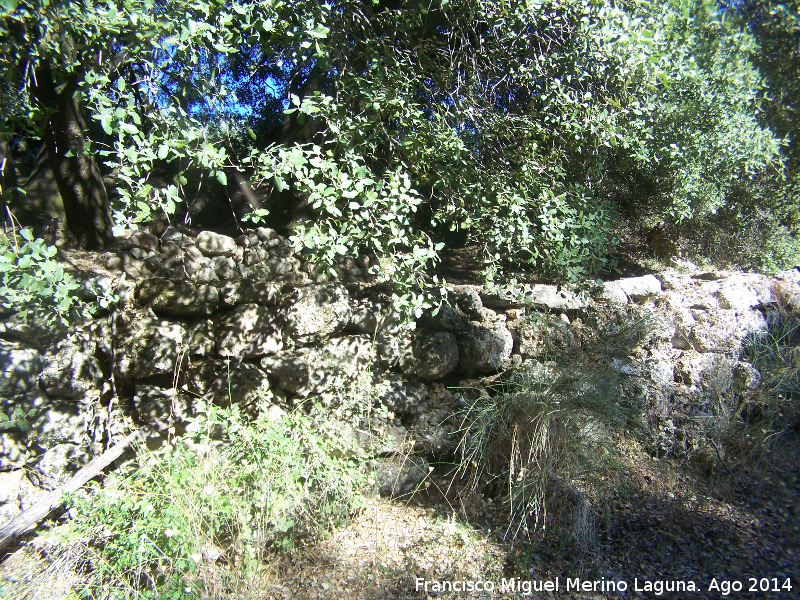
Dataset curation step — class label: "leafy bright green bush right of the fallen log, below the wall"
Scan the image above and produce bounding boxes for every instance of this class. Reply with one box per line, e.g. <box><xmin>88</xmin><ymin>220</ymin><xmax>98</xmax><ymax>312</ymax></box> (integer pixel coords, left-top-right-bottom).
<box><xmin>64</xmin><ymin>405</ymin><xmax>365</xmax><ymax>598</ymax></box>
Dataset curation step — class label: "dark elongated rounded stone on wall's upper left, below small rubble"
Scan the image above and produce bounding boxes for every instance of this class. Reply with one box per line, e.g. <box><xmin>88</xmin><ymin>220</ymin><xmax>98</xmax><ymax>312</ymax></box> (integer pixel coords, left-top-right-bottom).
<box><xmin>135</xmin><ymin>279</ymin><xmax>219</xmax><ymax>317</ymax></box>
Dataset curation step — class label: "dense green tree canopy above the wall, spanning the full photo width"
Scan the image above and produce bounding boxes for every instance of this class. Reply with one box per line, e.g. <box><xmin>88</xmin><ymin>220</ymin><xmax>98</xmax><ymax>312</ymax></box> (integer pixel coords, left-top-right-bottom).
<box><xmin>0</xmin><ymin>0</ymin><xmax>800</xmax><ymax>301</ymax></box>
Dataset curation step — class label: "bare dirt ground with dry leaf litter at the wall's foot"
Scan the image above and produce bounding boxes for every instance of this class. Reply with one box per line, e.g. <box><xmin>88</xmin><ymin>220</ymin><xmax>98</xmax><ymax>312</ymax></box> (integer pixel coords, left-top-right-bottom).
<box><xmin>260</xmin><ymin>433</ymin><xmax>800</xmax><ymax>600</ymax></box>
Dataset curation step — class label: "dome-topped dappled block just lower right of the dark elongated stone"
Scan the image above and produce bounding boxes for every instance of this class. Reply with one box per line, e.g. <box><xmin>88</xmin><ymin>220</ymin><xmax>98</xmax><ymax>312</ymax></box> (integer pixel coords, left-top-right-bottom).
<box><xmin>217</xmin><ymin>304</ymin><xmax>283</xmax><ymax>358</ymax></box>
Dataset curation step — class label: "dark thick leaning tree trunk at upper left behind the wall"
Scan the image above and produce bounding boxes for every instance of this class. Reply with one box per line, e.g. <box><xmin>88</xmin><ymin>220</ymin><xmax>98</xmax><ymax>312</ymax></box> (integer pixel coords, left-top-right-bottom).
<box><xmin>31</xmin><ymin>66</ymin><xmax>113</xmax><ymax>250</ymax></box>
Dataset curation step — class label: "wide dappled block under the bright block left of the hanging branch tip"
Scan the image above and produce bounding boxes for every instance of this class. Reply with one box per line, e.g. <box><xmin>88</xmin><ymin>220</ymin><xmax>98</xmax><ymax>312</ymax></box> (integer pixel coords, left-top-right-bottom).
<box><xmin>261</xmin><ymin>335</ymin><xmax>376</xmax><ymax>398</ymax></box>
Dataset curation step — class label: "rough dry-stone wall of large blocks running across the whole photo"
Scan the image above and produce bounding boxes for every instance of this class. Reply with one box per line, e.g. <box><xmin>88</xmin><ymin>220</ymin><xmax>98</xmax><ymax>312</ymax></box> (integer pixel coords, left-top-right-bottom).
<box><xmin>0</xmin><ymin>228</ymin><xmax>800</xmax><ymax>518</ymax></box>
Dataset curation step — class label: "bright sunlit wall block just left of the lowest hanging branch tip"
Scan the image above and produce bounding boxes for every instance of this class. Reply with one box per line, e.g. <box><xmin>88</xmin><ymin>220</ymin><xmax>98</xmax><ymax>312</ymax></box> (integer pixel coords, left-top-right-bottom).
<box><xmin>286</xmin><ymin>283</ymin><xmax>350</xmax><ymax>343</ymax></box>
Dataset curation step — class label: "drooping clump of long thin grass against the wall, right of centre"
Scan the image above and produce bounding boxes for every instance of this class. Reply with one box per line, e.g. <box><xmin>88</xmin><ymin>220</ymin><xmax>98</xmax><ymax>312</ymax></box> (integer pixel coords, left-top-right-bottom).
<box><xmin>458</xmin><ymin>353</ymin><xmax>638</xmax><ymax>546</ymax></box>
